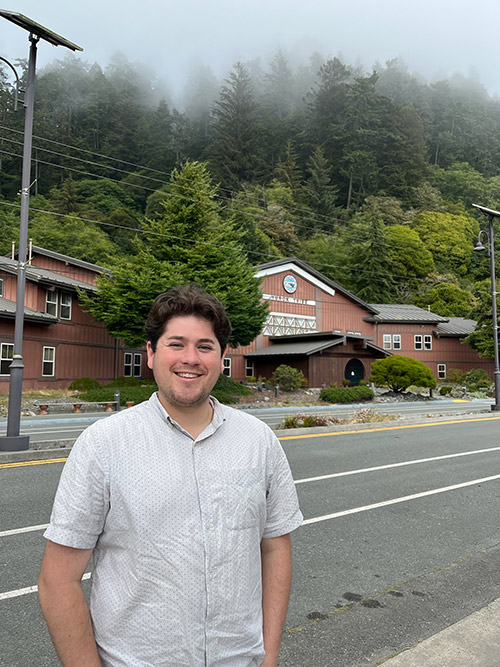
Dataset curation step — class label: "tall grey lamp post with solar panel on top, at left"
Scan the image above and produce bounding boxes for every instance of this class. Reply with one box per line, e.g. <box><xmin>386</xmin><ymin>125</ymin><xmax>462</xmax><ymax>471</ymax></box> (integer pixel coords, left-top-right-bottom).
<box><xmin>0</xmin><ymin>9</ymin><xmax>83</xmax><ymax>452</ymax></box>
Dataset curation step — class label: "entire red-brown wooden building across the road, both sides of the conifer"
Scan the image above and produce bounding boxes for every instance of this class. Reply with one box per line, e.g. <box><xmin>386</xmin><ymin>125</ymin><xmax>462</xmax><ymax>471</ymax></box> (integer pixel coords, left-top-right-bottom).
<box><xmin>0</xmin><ymin>252</ymin><xmax>493</xmax><ymax>392</ymax></box>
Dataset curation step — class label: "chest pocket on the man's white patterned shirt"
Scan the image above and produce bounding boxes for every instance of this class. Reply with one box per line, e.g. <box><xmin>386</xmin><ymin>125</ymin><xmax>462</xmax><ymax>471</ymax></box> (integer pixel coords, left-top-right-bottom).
<box><xmin>210</xmin><ymin>469</ymin><xmax>266</xmax><ymax>530</ymax></box>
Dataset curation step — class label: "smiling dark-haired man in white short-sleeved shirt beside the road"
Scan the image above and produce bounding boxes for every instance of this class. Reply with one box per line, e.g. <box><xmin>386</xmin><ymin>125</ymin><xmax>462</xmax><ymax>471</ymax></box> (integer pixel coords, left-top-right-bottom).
<box><xmin>39</xmin><ymin>285</ymin><xmax>302</xmax><ymax>667</ymax></box>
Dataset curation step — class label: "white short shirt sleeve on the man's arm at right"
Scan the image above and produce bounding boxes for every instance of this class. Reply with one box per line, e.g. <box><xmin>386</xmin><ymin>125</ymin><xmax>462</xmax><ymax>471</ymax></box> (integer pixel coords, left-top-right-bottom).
<box><xmin>262</xmin><ymin>434</ymin><xmax>303</xmax><ymax>538</ymax></box>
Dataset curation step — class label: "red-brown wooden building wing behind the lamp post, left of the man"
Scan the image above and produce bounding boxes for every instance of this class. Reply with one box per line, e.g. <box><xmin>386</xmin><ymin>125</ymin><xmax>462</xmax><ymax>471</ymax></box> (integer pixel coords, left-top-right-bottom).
<box><xmin>0</xmin><ymin>246</ymin><xmax>149</xmax><ymax>392</ymax></box>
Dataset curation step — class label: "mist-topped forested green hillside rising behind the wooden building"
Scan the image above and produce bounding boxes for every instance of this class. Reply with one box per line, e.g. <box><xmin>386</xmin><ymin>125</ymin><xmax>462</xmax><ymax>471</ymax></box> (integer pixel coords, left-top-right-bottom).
<box><xmin>0</xmin><ymin>51</ymin><xmax>500</xmax><ymax>353</ymax></box>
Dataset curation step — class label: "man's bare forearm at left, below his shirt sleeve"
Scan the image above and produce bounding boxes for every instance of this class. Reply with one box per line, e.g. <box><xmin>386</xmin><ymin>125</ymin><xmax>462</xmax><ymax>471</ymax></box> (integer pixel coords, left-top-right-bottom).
<box><xmin>38</xmin><ymin>580</ymin><xmax>101</xmax><ymax>667</ymax></box>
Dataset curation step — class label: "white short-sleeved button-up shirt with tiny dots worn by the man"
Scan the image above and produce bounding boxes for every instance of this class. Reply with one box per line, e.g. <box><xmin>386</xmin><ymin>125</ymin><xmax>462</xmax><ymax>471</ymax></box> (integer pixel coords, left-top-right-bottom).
<box><xmin>44</xmin><ymin>394</ymin><xmax>302</xmax><ymax>667</ymax></box>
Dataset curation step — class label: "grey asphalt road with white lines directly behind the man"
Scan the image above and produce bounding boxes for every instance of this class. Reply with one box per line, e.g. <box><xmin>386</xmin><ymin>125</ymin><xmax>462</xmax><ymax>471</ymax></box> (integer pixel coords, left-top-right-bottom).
<box><xmin>0</xmin><ymin>415</ymin><xmax>500</xmax><ymax>667</ymax></box>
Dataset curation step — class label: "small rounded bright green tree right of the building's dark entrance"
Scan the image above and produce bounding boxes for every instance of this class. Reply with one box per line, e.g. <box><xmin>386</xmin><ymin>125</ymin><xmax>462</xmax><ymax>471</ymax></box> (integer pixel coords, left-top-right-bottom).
<box><xmin>370</xmin><ymin>354</ymin><xmax>436</xmax><ymax>392</ymax></box>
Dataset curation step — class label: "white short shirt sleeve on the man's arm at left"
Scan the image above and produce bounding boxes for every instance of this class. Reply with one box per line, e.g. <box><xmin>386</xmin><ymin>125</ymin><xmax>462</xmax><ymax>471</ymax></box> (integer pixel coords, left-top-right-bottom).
<box><xmin>44</xmin><ymin>427</ymin><xmax>109</xmax><ymax>549</ymax></box>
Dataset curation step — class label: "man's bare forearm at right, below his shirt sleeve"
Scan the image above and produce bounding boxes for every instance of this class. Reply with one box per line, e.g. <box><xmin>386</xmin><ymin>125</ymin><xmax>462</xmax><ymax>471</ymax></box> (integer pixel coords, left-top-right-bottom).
<box><xmin>262</xmin><ymin>535</ymin><xmax>292</xmax><ymax>667</ymax></box>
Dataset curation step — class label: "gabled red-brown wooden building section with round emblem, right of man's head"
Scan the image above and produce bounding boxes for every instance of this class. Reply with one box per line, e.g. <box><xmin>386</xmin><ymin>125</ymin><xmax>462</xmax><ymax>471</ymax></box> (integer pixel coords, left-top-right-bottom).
<box><xmin>228</xmin><ymin>258</ymin><xmax>493</xmax><ymax>387</ymax></box>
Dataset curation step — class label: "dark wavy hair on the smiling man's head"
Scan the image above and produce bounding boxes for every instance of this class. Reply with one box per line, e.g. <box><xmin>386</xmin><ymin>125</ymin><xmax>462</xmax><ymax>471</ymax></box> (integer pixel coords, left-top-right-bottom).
<box><xmin>145</xmin><ymin>283</ymin><xmax>231</xmax><ymax>352</ymax></box>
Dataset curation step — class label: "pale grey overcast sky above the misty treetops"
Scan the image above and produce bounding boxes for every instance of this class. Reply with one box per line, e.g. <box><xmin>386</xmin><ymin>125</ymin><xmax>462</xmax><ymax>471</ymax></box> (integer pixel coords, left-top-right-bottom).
<box><xmin>0</xmin><ymin>0</ymin><xmax>500</xmax><ymax>95</ymax></box>
